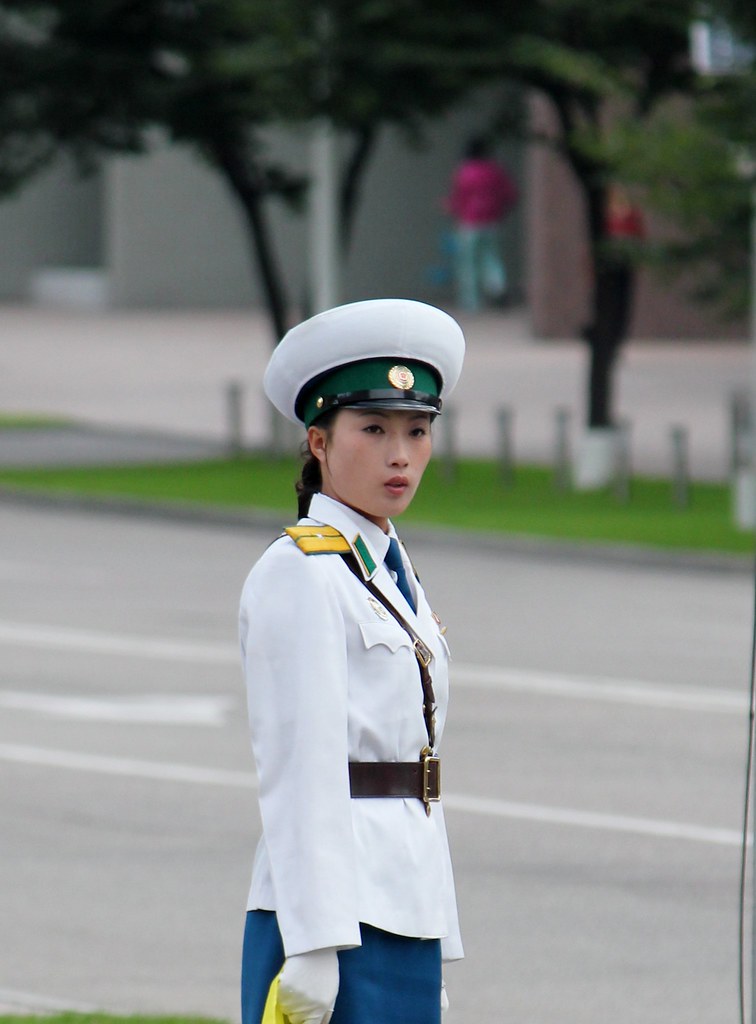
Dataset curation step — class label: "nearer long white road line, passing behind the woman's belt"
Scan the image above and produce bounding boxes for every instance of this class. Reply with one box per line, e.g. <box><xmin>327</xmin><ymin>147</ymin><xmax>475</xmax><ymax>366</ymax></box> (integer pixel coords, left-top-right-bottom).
<box><xmin>0</xmin><ymin>743</ymin><xmax>743</xmax><ymax>846</ymax></box>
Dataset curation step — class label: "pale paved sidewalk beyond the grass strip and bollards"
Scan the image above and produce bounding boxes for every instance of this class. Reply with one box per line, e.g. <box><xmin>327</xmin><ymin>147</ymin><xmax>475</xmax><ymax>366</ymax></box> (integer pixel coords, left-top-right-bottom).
<box><xmin>0</xmin><ymin>306</ymin><xmax>752</xmax><ymax>480</ymax></box>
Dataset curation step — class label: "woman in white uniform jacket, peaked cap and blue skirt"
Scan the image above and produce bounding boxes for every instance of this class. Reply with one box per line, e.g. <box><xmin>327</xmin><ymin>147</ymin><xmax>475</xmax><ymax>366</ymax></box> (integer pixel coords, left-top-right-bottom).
<box><xmin>240</xmin><ymin>299</ymin><xmax>464</xmax><ymax>1024</ymax></box>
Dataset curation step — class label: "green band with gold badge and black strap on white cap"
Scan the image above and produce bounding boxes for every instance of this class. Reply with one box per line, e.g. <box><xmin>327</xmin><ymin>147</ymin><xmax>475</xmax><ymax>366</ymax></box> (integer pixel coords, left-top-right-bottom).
<box><xmin>297</xmin><ymin>357</ymin><xmax>440</xmax><ymax>427</ymax></box>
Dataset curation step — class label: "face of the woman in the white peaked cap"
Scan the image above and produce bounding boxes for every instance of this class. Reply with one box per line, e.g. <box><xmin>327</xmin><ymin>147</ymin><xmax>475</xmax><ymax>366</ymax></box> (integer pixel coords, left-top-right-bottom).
<box><xmin>307</xmin><ymin>409</ymin><xmax>431</xmax><ymax>530</ymax></box>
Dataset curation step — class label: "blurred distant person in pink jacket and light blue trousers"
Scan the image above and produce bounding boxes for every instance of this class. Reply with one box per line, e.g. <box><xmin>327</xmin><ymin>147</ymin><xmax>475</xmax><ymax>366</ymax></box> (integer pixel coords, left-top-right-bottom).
<box><xmin>446</xmin><ymin>137</ymin><xmax>517</xmax><ymax>312</ymax></box>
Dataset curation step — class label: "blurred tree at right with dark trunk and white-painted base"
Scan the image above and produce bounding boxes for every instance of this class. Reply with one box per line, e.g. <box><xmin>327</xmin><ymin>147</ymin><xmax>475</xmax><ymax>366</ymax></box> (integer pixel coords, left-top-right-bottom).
<box><xmin>379</xmin><ymin>0</ymin><xmax>737</xmax><ymax>448</ymax></box>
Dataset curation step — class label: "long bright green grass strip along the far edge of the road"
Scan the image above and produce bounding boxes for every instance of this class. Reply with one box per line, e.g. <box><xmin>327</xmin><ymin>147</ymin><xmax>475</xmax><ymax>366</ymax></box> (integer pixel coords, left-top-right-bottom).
<box><xmin>0</xmin><ymin>456</ymin><xmax>754</xmax><ymax>553</ymax></box>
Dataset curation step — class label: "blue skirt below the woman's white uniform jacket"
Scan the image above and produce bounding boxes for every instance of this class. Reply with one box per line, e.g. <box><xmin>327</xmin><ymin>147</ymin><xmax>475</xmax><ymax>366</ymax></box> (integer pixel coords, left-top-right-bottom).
<box><xmin>242</xmin><ymin>910</ymin><xmax>442</xmax><ymax>1024</ymax></box>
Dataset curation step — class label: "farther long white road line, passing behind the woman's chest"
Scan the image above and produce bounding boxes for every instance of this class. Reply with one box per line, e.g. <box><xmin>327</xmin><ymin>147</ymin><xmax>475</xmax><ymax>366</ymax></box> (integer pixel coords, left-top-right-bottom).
<box><xmin>0</xmin><ymin>622</ymin><xmax>748</xmax><ymax>715</ymax></box>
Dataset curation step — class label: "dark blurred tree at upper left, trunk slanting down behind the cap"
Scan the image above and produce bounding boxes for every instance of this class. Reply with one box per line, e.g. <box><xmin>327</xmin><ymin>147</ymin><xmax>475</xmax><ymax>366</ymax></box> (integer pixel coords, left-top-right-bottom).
<box><xmin>0</xmin><ymin>0</ymin><xmax>489</xmax><ymax>340</ymax></box>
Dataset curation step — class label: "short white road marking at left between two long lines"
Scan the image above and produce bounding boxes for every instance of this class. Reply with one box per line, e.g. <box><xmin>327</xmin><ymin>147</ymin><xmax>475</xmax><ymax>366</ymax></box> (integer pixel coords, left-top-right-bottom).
<box><xmin>0</xmin><ymin>690</ymin><xmax>234</xmax><ymax>726</ymax></box>
